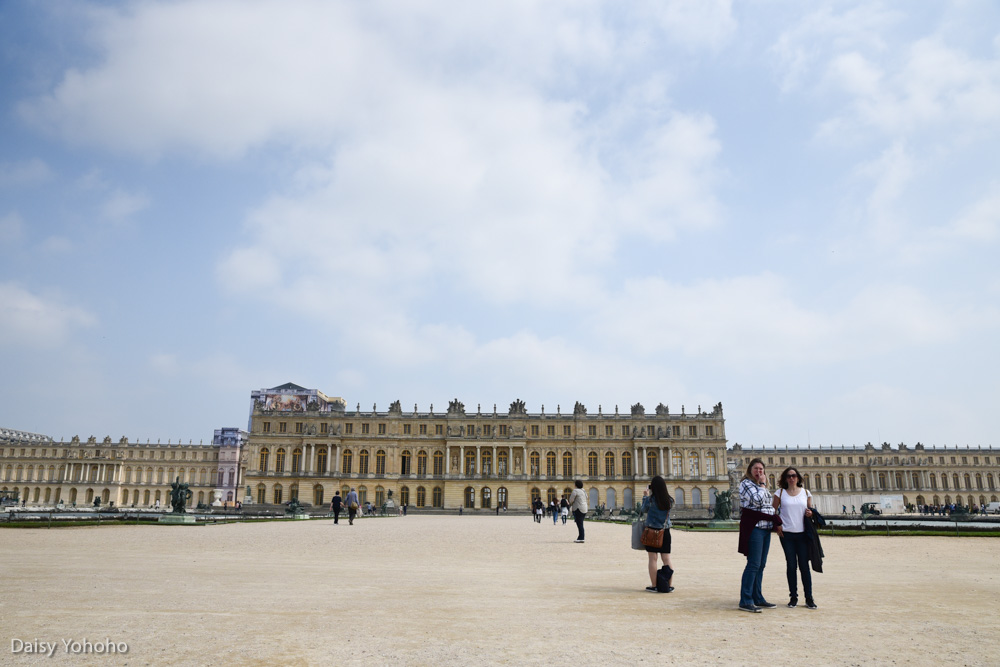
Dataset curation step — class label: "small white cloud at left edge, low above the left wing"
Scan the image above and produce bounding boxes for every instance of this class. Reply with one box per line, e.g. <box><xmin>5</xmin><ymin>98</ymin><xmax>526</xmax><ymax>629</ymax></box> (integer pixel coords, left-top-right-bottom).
<box><xmin>0</xmin><ymin>282</ymin><xmax>97</xmax><ymax>347</ymax></box>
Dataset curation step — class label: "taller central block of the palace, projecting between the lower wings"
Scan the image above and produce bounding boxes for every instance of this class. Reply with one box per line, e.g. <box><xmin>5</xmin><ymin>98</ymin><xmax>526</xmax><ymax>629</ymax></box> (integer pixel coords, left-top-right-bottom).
<box><xmin>246</xmin><ymin>384</ymin><xmax>729</xmax><ymax>510</ymax></box>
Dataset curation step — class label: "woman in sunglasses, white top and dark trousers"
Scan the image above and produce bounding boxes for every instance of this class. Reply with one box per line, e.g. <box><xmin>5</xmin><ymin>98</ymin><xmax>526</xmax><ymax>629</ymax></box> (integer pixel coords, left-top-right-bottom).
<box><xmin>773</xmin><ymin>468</ymin><xmax>816</xmax><ymax>609</ymax></box>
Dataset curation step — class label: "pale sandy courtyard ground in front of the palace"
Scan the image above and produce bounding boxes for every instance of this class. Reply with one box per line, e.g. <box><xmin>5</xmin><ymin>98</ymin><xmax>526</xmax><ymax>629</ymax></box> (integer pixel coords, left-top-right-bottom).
<box><xmin>0</xmin><ymin>516</ymin><xmax>1000</xmax><ymax>665</ymax></box>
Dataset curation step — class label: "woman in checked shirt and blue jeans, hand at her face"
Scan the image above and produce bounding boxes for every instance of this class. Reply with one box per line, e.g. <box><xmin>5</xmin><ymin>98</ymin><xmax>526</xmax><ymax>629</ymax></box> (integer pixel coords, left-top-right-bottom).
<box><xmin>739</xmin><ymin>459</ymin><xmax>781</xmax><ymax>613</ymax></box>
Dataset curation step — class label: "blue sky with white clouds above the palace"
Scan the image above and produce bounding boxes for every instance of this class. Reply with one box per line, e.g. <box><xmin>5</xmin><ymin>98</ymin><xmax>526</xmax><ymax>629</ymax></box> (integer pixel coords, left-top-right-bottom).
<box><xmin>0</xmin><ymin>0</ymin><xmax>1000</xmax><ymax>447</ymax></box>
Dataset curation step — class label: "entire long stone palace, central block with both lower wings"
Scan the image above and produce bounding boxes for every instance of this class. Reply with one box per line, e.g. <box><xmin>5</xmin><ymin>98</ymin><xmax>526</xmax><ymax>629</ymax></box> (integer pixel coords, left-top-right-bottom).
<box><xmin>0</xmin><ymin>383</ymin><xmax>1000</xmax><ymax>511</ymax></box>
